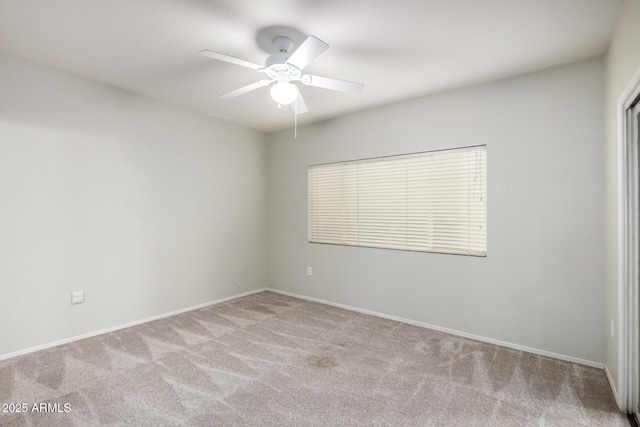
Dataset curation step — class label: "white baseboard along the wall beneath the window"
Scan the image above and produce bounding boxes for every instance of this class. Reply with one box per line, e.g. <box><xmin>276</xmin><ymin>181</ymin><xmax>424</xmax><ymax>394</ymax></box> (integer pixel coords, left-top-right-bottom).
<box><xmin>266</xmin><ymin>288</ymin><xmax>605</xmax><ymax>369</ymax></box>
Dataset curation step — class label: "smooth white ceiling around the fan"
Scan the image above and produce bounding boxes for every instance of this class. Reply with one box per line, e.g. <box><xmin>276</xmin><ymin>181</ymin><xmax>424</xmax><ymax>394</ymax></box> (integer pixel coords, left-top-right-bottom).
<box><xmin>0</xmin><ymin>0</ymin><xmax>622</xmax><ymax>132</ymax></box>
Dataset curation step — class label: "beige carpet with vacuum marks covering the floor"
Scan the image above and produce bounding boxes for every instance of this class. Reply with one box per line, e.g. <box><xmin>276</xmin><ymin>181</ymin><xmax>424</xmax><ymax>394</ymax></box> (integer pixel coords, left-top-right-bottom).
<box><xmin>0</xmin><ymin>292</ymin><xmax>629</xmax><ymax>427</ymax></box>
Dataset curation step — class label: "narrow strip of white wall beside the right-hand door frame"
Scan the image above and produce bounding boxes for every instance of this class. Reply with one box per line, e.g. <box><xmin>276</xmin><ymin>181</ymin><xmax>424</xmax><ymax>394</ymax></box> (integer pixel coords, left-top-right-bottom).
<box><xmin>605</xmin><ymin>0</ymin><xmax>640</xmax><ymax>400</ymax></box>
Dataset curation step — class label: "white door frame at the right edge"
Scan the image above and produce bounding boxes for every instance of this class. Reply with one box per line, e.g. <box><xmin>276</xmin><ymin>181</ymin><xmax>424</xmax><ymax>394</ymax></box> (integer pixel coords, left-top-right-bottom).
<box><xmin>618</xmin><ymin>65</ymin><xmax>640</xmax><ymax>412</ymax></box>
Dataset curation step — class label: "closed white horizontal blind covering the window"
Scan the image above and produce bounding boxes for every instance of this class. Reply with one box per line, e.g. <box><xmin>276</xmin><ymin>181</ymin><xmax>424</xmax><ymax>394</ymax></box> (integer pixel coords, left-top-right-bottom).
<box><xmin>309</xmin><ymin>146</ymin><xmax>487</xmax><ymax>256</ymax></box>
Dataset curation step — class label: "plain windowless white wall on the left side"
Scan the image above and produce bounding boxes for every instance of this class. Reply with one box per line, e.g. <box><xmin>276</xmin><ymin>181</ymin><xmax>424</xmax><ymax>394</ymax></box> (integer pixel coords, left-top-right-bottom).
<box><xmin>0</xmin><ymin>54</ymin><xmax>267</xmax><ymax>356</ymax></box>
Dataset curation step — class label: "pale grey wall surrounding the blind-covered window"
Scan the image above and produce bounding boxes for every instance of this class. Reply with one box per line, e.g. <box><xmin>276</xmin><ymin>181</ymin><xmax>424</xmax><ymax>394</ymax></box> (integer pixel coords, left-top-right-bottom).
<box><xmin>269</xmin><ymin>58</ymin><xmax>605</xmax><ymax>363</ymax></box>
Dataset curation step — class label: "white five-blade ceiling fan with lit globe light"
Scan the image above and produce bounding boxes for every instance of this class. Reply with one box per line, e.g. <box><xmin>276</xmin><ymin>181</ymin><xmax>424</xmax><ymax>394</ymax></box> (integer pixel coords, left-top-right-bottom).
<box><xmin>200</xmin><ymin>36</ymin><xmax>364</xmax><ymax>115</ymax></box>
